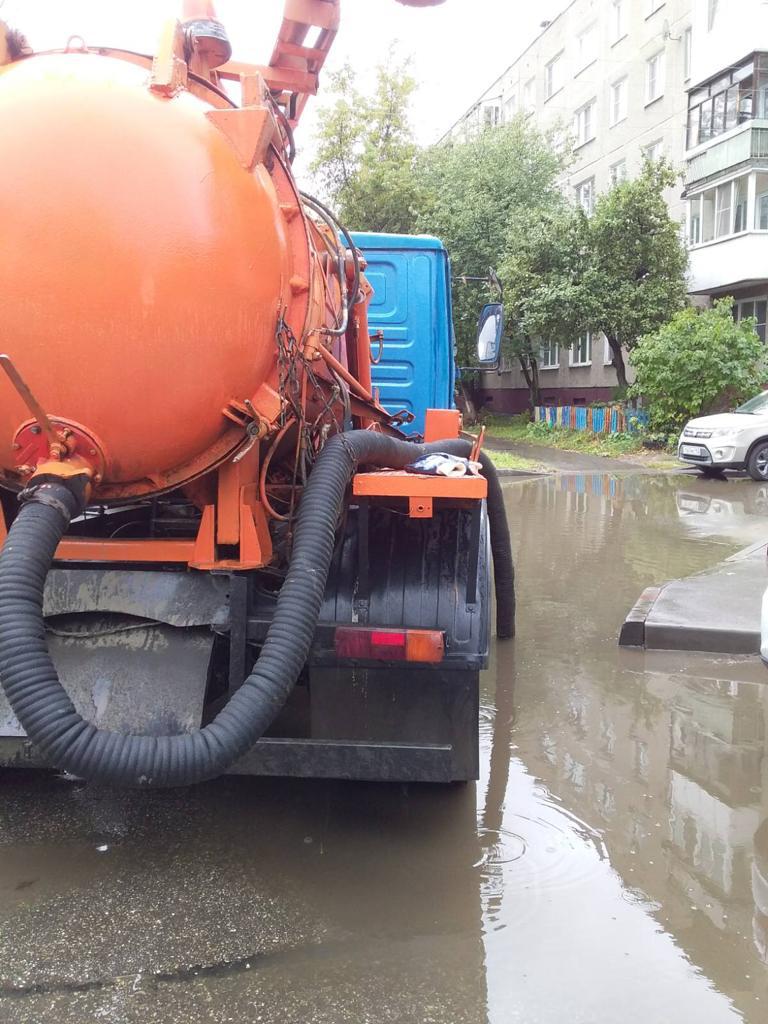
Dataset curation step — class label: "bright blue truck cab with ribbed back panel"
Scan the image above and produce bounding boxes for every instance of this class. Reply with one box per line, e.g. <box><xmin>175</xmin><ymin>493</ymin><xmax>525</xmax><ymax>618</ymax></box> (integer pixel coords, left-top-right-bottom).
<box><xmin>352</xmin><ymin>232</ymin><xmax>456</xmax><ymax>434</ymax></box>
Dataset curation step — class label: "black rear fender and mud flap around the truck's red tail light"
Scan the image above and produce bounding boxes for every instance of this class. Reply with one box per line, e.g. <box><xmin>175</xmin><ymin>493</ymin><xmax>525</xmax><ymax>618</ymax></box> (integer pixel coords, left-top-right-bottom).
<box><xmin>301</xmin><ymin>504</ymin><xmax>490</xmax><ymax>782</ymax></box>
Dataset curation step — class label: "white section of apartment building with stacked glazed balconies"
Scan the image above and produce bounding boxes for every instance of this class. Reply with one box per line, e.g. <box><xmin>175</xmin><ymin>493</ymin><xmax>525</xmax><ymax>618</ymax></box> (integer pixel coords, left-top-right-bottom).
<box><xmin>685</xmin><ymin>0</ymin><xmax>768</xmax><ymax>341</ymax></box>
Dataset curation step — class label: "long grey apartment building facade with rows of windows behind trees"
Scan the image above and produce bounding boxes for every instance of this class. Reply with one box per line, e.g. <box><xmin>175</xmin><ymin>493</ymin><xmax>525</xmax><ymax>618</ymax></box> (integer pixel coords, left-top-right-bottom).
<box><xmin>445</xmin><ymin>0</ymin><xmax>696</xmax><ymax>413</ymax></box>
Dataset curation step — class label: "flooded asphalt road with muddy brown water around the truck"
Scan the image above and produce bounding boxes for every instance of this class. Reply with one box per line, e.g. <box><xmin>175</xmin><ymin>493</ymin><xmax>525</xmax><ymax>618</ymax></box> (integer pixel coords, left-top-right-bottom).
<box><xmin>0</xmin><ymin>473</ymin><xmax>768</xmax><ymax>1024</ymax></box>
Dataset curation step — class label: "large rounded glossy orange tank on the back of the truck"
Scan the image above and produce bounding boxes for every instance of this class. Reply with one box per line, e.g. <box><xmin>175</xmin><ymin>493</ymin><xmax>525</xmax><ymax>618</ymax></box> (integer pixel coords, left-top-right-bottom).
<box><xmin>0</xmin><ymin>52</ymin><xmax>324</xmax><ymax>498</ymax></box>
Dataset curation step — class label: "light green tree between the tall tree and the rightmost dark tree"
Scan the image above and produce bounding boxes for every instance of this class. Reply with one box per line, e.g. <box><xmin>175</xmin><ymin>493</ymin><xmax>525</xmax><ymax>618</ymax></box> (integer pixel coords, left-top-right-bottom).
<box><xmin>500</xmin><ymin>194</ymin><xmax>592</xmax><ymax>408</ymax></box>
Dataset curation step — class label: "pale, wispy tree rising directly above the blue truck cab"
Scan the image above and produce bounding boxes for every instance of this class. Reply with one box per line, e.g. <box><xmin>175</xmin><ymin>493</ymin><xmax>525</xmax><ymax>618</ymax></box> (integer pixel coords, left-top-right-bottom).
<box><xmin>310</xmin><ymin>51</ymin><xmax>423</xmax><ymax>232</ymax></box>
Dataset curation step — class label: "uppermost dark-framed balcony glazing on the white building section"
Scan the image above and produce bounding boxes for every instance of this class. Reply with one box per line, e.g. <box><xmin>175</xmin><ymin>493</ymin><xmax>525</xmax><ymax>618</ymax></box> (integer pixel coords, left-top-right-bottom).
<box><xmin>688</xmin><ymin>53</ymin><xmax>768</xmax><ymax>150</ymax></box>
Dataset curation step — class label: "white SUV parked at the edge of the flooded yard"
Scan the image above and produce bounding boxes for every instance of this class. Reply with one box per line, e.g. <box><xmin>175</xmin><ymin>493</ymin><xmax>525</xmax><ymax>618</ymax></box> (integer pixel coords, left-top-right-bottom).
<box><xmin>677</xmin><ymin>391</ymin><xmax>768</xmax><ymax>480</ymax></box>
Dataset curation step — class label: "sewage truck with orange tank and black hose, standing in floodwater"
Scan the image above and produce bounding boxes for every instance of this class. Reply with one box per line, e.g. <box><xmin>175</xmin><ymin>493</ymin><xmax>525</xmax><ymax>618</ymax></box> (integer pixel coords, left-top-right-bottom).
<box><xmin>0</xmin><ymin>0</ymin><xmax>514</xmax><ymax>786</ymax></box>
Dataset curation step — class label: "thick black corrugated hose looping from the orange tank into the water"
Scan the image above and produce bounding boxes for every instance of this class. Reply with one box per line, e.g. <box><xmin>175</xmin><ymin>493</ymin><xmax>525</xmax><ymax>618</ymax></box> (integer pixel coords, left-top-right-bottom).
<box><xmin>0</xmin><ymin>430</ymin><xmax>514</xmax><ymax>787</ymax></box>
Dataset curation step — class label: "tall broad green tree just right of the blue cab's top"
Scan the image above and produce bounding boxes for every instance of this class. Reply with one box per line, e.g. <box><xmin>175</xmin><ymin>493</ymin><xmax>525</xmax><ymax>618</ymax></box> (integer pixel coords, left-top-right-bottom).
<box><xmin>416</xmin><ymin>117</ymin><xmax>566</xmax><ymax>366</ymax></box>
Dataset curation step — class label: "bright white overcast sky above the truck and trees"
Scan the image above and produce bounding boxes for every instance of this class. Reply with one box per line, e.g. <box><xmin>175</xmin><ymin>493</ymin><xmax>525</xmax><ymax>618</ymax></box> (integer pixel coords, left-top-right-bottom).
<box><xmin>0</xmin><ymin>0</ymin><xmax>567</xmax><ymax>153</ymax></box>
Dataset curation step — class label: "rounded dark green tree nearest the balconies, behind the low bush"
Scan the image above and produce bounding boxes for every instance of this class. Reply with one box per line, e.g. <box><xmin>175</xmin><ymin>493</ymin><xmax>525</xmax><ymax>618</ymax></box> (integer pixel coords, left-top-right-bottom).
<box><xmin>584</xmin><ymin>162</ymin><xmax>688</xmax><ymax>388</ymax></box>
